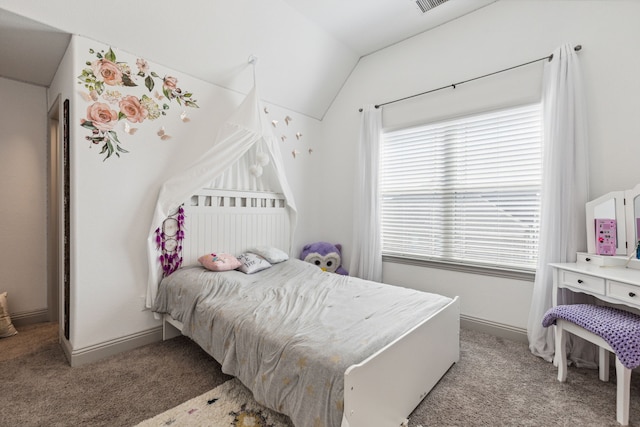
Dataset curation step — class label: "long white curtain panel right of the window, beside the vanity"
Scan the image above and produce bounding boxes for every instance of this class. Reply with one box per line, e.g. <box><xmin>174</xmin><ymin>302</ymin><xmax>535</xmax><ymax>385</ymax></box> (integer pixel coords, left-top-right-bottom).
<box><xmin>527</xmin><ymin>44</ymin><xmax>595</xmax><ymax>367</ymax></box>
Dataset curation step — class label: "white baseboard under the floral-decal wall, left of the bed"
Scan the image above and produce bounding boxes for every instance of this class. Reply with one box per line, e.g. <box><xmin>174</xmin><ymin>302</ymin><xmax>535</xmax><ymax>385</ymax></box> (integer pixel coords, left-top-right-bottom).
<box><xmin>61</xmin><ymin>326</ymin><xmax>162</xmax><ymax>367</ymax></box>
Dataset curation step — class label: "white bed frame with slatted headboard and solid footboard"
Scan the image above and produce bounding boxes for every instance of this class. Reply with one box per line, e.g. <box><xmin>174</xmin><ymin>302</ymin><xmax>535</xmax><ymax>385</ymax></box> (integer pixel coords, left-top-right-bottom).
<box><xmin>163</xmin><ymin>189</ymin><xmax>460</xmax><ymax>427</ymax></box>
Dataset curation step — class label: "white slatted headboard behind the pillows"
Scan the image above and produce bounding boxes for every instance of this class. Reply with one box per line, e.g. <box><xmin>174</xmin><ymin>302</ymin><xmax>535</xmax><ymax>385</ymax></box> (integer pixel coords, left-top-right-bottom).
<box><xmin>182</xmin><ymin>188</ymin><xmax>291</xmax><ymax>266</ymax></box>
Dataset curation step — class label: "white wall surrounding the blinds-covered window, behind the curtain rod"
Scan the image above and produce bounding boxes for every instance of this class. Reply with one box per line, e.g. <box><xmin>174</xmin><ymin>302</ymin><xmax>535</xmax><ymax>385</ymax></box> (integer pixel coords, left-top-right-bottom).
<box><xmin>318</xmin><ymin>0</ymin><xmax>640</xmax><ymax>330</ymax></box>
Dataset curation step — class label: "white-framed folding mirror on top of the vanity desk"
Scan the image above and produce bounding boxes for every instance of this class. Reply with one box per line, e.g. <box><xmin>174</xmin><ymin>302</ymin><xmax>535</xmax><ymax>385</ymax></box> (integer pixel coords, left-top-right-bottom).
<box><xmin>585</xmin><ymin>184</ymin><xmax>640</xmax><ymax>257</ymax></box>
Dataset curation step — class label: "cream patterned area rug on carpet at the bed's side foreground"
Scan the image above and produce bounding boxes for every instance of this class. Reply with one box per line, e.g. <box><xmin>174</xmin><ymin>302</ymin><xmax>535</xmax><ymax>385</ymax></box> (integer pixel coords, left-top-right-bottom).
<box><xmin>138</xmin><ymin>378</ymin><xmax>293</xmax><ymax>427</ymax></box>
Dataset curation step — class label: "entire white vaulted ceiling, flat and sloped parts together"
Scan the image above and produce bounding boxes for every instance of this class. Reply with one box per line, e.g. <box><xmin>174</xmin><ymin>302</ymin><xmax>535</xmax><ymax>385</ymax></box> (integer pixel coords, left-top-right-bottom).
<box><xmin>0</xmin><ymin>0</ymin><xmax>495</xmax><ymax>119</ymax></box>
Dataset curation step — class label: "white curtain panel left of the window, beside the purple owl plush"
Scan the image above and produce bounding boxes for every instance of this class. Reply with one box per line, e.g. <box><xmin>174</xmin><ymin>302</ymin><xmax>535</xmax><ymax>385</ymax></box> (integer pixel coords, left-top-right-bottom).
<box><xmin>349</xmin><ymin>105</ymin><xmax>382</xmax><ymax>282</ymax></box>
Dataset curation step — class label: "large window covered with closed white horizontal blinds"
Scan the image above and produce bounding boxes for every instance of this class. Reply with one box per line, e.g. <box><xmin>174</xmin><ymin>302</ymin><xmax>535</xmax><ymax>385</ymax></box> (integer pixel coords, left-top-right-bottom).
<box><xmin>380</xmin><ymin>104</ymin><xmax>542</xmax><ymax>271</ymax></box>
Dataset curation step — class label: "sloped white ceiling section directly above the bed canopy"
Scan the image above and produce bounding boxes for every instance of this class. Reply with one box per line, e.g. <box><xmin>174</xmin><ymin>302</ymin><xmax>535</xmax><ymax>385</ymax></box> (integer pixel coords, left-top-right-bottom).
<box><xmin>0</xmin><ymin>0</ymin><xmax>358</xmax><ymax>119</ymax></box>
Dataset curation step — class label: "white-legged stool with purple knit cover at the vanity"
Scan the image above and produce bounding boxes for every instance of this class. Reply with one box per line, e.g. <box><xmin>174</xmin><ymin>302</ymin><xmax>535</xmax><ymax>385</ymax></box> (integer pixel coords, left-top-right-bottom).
<box><xmin>542</xmin><ymin>304</ymin><xmax>640</xmax><ymax>426</ymax></box>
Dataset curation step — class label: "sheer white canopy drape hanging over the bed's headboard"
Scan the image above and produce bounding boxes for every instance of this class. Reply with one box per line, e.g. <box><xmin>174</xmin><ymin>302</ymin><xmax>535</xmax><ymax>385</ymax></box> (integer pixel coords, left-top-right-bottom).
<box><xmin>146</xmin><ymin>86</ymin><xmax>297</xmax><ymax>308</ymax></box>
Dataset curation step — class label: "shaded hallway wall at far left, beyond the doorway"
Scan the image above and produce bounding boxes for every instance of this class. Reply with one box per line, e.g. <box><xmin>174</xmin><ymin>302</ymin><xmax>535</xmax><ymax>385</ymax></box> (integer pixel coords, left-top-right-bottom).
<box><xmin>0</xmin><ymin>78</ymin><xmax>47</xmax><ymax>318</ymax></box>
